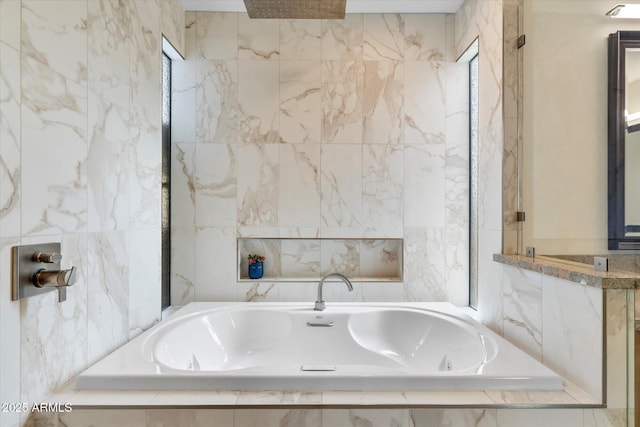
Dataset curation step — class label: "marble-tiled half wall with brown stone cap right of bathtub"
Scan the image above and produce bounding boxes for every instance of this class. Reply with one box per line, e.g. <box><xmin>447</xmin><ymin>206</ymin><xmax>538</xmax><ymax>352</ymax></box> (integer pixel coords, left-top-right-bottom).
<box><xmin>494</xmin><ymin>255</ymin><xmax>640</xmax><ymax>416</ymax></box>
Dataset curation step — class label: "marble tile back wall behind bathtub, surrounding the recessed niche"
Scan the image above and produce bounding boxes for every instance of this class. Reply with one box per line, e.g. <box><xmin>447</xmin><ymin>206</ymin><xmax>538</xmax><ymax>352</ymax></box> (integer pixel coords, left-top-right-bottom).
<box><xmin>172</xmin><ymin>12</ymin><xmax>468</xmax><ymax>305</ymax></box>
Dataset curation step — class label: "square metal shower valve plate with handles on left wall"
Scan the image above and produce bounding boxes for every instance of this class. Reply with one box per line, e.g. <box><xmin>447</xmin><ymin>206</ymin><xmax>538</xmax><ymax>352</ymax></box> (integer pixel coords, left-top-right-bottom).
<box><xmin>11</xmin><ymin>243</ymin><xmax>77</xmax><ymax>302</ymax></box>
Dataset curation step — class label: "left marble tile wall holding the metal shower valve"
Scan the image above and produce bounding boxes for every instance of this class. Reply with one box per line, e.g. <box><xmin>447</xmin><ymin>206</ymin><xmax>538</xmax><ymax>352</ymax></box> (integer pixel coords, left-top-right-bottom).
<box><xmin>0</xmin><ymin>0</ymin><xmax>184</xmax><ymax>426</ymax></box>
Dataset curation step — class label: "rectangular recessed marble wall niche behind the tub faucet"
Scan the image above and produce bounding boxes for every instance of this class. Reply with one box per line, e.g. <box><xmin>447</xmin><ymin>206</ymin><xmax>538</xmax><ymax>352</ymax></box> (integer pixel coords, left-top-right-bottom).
<box><xmin>238</xmin><ymin>238</ymin><xmax>403</xmax><ymax>282</ymax></box>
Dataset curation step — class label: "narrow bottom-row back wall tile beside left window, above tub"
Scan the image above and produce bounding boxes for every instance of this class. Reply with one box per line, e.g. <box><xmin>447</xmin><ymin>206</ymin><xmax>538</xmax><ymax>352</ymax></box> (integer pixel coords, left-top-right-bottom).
<box><xmin>171</xmin><ymin>226</ymin><xmax>196</xmax><ymax>306</ymax></box>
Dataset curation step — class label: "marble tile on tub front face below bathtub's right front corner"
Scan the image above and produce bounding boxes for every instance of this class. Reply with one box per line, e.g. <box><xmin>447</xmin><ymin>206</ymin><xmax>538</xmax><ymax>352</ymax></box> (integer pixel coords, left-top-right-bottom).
<box><xmin>497</xmin><ymin>409</ymin><xmax>583</xmax><ymax>427</ymax></box>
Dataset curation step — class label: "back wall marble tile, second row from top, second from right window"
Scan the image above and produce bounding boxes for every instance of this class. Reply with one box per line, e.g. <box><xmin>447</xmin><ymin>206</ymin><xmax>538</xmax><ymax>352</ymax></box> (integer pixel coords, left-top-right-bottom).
<box><xmin>404</xmin><ymin>57</ymin><xmax>446</xmax><ymax>144</ymax></box>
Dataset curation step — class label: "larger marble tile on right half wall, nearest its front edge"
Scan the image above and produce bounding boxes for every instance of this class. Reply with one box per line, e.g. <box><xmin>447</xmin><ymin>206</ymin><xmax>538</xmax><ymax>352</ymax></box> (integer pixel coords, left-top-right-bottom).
<box><xmin>542</xmin><ymin>276</ymin><xmax>604</xmax><ymax>399</ymax></box>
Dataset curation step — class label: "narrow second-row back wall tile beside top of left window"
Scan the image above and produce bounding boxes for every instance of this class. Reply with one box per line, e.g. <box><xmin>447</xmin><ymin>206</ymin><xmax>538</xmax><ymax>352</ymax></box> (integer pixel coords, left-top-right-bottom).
<box><xmin>171</xmin><ymin>60</ymin><xmax>196</xmax><ymax>143</ymax></box>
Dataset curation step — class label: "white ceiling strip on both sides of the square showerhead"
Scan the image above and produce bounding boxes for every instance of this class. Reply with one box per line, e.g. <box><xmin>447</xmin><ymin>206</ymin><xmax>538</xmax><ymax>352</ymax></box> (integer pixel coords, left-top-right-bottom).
<box><xmin>180</xmin><ymin>0</ymin><xmax>463</xmax><ymax>13</ymax></box>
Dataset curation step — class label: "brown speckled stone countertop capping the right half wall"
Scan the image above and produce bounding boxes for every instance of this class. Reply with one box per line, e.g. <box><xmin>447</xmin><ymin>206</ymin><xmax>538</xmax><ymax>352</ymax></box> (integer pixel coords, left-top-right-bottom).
<box><xmin>493</xmin><ymin>254</ymin><xmax>640</xmax><ymax>289</ymax></box>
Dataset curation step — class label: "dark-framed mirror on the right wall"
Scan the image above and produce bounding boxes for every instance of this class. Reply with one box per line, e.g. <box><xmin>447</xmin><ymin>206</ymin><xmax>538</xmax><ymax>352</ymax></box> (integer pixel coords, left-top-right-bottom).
<box><xmin>608</xmin><ymin>31</ymin><xmax>640</xmax><ymax>250</ymax></box>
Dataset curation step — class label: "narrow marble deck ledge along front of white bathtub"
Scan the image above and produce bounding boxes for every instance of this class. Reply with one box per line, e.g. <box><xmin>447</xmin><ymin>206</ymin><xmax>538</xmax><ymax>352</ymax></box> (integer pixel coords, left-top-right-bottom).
<box><xmin>47</xmin><ymin>380</ymin><xmax>603</xmax><ymax>409</ymax></box>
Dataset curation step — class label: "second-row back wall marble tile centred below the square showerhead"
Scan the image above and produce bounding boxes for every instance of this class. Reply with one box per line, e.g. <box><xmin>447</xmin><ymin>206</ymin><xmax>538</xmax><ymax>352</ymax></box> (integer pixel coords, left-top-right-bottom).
<box><xmin>280</xmin><ymin>61</ymin><xmax>322</xmax><ymax>143</ymax></box>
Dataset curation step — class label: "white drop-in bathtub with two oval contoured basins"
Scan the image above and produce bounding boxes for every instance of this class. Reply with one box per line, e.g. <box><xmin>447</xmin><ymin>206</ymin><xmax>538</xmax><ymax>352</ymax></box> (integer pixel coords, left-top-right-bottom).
<box><xmin>76</xmin><ymin>303</ymin><xmax>562</xmax><ymax>391</ymax></box>
